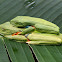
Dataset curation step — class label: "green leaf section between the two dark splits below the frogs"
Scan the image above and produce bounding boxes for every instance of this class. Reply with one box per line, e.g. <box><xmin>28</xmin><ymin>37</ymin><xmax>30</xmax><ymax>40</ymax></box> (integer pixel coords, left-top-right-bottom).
<box><xmin>5</xmin><ymin>39</ymin><xmax>34</xmax><ymax>62</ymax></box>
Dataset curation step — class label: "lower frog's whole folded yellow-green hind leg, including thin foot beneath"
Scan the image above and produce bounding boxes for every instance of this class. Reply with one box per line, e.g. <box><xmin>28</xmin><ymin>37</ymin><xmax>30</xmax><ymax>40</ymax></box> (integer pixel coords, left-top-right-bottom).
<box><xmin>27</xmin><ymin>33</ymin><xmax>62</xmax><ymax>44</ymax></box>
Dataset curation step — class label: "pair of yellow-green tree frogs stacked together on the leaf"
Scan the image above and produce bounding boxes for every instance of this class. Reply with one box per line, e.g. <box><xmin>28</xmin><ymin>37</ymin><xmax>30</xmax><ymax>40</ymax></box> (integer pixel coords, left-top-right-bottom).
<box><xmin>0</xmin><ymin>16</ymin><xmax>62</xmax><ymax>45</ymax></box>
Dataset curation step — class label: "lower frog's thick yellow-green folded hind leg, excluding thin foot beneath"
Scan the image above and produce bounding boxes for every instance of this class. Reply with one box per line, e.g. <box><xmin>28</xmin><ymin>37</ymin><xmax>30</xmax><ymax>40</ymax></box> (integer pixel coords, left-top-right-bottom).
<box><xmin>27</xmin><ymin>33</ymin><xmax>61</xmax><ymax>42</ymax></box>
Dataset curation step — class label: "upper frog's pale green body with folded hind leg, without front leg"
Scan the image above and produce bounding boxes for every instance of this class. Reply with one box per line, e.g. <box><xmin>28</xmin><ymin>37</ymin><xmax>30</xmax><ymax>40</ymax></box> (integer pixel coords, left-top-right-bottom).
<box><xmin>10</xmin><ymin>16</ymin><xmax>59</xmax><ymax>34</ymax></box>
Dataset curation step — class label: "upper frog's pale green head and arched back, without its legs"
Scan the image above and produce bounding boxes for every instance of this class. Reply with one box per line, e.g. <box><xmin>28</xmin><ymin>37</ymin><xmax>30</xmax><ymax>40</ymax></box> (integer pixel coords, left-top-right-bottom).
<box><xmin>10</xmin><ymin>16</ymin><xmax>59</xmax><ymax>28</ymax></box>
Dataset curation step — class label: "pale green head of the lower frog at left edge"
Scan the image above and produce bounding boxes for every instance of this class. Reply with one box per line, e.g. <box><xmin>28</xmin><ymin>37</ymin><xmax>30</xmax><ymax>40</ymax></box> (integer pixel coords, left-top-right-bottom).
<box><xmin>0</xmin><ymin>22</ymin><xmax>23</xmax><ymax>35</ymax></box>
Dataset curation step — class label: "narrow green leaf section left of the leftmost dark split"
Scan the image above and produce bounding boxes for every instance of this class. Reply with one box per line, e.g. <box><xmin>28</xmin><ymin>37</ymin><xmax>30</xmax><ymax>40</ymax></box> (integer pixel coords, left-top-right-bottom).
<box><xmin>0</xmin><ymin>36</ymin><xmax>10</xmax><ymax>62</ymax></box>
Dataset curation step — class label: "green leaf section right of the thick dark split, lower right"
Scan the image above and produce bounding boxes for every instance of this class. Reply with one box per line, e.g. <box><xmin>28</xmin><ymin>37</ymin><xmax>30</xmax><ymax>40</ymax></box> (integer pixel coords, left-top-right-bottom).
<box><xmin>31</xmin><ymin>45</ymin><xmax>62</xmax><ymax>62</ymax></box>
